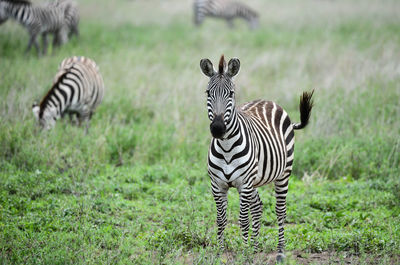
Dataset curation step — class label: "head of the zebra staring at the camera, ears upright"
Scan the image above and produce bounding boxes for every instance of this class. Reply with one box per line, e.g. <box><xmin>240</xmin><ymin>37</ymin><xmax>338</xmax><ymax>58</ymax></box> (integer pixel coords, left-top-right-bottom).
<box><xmin>200</xmin><ymin>55</ymin><xmax>240</xmax><ymax>139</ymax></box>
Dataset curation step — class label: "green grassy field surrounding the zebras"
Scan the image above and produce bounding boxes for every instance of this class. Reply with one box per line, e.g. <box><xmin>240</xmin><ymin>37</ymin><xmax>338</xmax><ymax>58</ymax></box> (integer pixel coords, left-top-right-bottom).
<box><xmin>0</xmin><ymin>0</ymin><xmax>400</xmax><ymax>264</ymax></box>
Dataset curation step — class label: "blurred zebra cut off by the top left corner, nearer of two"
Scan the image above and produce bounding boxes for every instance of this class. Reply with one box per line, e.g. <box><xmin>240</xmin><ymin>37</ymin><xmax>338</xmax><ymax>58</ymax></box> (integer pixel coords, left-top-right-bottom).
<box><xmin>0</xmin><ymin>0</ymin><xmax>67</xmax><ymax>55</ymax></box>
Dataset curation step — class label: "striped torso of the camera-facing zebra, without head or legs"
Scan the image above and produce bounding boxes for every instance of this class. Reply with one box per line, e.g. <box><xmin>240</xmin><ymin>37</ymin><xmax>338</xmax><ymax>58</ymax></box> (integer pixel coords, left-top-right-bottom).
<box><xmin>208</xmin><ymin>100</ymin><xmax>294</xmax><ymax>188</ymax></box>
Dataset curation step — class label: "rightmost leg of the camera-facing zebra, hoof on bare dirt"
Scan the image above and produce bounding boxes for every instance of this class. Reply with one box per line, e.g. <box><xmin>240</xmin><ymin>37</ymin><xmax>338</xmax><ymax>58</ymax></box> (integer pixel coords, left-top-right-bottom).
<box><xmin>275</xmin><ymin>172</ymin><xmax>290</xmax><ymax>262</ymax></box>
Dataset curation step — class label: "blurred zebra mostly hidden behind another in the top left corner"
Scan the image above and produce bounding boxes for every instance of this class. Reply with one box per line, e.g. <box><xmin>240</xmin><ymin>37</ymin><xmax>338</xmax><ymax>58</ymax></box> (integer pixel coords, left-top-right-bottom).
<box><xmin>48</xmin><ymin>0</ymin><xmax>80</xmax><ymax>44</ymax></box>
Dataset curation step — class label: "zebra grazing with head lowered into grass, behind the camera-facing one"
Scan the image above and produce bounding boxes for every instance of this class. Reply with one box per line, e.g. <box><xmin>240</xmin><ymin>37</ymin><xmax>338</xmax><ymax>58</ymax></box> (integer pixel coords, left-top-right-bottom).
<box><xmin>32</xmin><ymin>57</ymin><xmax>104</xmax><ymax>133</ymax></box>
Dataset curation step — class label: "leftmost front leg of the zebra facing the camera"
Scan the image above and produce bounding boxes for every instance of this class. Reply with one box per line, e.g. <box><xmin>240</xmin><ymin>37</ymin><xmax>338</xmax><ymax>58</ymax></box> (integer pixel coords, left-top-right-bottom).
<box><xmin>211</xmin><ymin>182</ymin><xmax>228</xmax><ymax>250</ymax></box>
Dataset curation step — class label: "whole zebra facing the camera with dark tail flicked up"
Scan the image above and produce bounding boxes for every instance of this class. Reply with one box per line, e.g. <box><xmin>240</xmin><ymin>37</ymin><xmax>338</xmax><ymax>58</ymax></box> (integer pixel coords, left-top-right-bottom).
<box><xmin>200</xmin><ymin>56</ymin><xmax>313</xmax><ymax>261</ymax></box>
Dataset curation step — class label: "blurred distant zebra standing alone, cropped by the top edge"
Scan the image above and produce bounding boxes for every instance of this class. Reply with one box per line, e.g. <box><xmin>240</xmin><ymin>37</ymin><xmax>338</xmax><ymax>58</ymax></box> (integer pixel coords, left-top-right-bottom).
<box><xmin>194</xmin><ymin>0</ymin><xmax>258</xmax><ymax>29</ymax></box>
